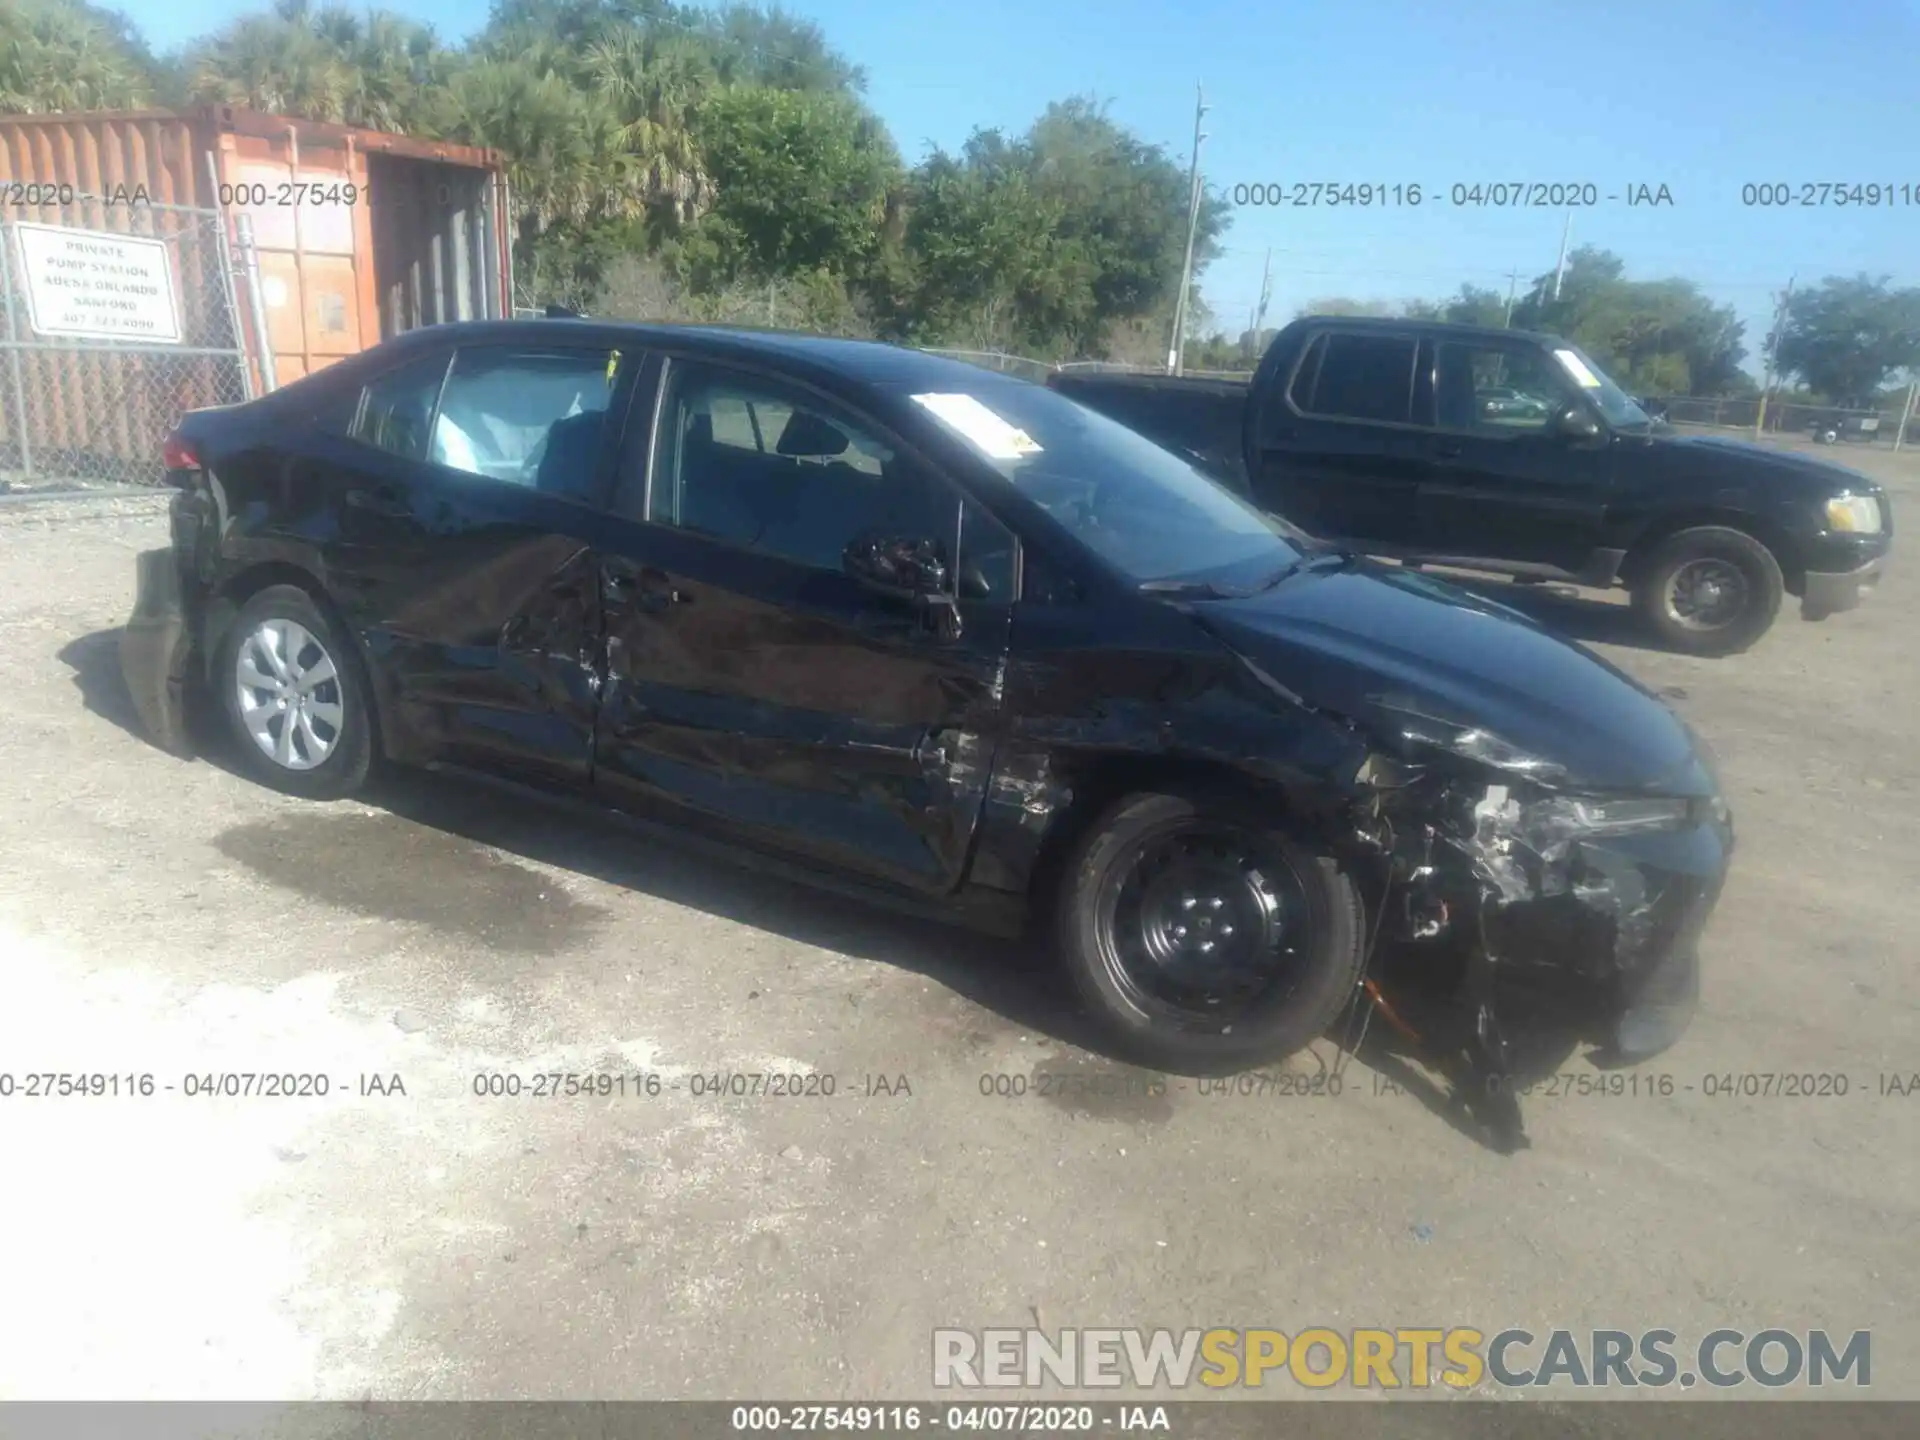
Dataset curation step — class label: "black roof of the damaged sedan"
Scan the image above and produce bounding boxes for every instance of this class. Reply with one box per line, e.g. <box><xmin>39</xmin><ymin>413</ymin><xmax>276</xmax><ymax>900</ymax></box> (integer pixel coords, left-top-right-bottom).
<box><xmin>362</xmin><ymin>317</ymin><xmax>1016</xmax><ymax>390</ymax></box>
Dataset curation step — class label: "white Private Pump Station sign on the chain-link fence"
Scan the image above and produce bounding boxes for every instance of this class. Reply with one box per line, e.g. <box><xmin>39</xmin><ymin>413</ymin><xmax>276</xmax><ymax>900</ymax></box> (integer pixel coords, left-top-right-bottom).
<box><xmin>13</xmin><ymin>223</ymin><xmax>180</xmax><ymax>344</ymax></box>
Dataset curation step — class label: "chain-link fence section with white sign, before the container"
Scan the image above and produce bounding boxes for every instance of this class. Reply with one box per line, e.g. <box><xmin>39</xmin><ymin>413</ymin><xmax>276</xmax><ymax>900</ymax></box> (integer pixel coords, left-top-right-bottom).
<box><xmin>0</xmin><ymin>186</ymin><xmax>253</xmax><ymax>490</ymax></box>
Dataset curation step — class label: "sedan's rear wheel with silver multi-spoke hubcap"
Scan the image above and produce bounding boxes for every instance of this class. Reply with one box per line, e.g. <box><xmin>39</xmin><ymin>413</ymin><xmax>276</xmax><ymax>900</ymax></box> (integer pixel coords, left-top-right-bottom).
<box><xmin>213</xmin><ymin>586</ymin><xmax>374</xmax><ymax>814</ymax></box>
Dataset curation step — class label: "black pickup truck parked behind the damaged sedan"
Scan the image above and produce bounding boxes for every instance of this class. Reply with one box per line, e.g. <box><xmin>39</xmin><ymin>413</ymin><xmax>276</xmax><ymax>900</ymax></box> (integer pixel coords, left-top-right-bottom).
<box><xmin>1048</xmin><ymin>317</ymin><xmax>1893</xmax><ymax>655</ymax></box>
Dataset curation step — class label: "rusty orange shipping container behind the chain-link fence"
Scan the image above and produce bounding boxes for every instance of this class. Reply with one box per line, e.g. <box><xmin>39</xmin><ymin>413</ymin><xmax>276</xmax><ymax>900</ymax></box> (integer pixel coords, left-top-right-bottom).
<box><xmin>0</xmin><ymin>106</ymin><xmax>513</xmax><ymax>487</ymax></box>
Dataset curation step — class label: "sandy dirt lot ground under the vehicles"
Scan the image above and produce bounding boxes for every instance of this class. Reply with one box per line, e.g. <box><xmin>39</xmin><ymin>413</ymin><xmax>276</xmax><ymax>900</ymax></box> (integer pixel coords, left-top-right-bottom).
<box><xmin>0</xmin><ymin>455</ymin><xmax>1920</xmax><ymax>1398</ymax></box>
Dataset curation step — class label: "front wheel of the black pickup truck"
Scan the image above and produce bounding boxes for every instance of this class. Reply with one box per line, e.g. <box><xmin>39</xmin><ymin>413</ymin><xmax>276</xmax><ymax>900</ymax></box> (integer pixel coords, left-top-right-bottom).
<box><xmin>1634</xmin><ymin>524</ymin><xmax>1786</xmax><ymax>655</ymax></box>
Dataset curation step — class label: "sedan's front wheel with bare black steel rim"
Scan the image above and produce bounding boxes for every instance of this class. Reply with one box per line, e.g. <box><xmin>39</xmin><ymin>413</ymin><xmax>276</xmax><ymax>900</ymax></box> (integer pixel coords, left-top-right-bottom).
<box><xmin>1058</xmin><ymin>789</ymin><xmax>1367</xmax><ymax>1075</ymax></box>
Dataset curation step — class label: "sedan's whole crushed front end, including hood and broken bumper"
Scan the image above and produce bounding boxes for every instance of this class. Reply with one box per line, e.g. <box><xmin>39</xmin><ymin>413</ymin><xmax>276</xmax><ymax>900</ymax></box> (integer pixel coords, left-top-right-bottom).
<box><xmin>1190</xmin><ymin>557</ymin><xmax>1734</xmax><ymax>1148</ymax></box>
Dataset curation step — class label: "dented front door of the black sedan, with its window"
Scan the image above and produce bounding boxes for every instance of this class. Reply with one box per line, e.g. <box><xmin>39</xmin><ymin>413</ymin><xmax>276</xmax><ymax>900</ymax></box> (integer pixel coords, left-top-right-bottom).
<box><xmin>593</xmin><ymin>359</ymin><xmax>1014</xmax><ymax>895</ymax></box>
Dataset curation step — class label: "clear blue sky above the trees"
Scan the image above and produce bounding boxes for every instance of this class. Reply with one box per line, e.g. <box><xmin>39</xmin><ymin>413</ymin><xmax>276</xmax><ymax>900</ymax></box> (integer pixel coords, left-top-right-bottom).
<box><xmin>120</xmin><ymin>0</ymin><xmax>1920</xmax><ymax>365</ymax></box>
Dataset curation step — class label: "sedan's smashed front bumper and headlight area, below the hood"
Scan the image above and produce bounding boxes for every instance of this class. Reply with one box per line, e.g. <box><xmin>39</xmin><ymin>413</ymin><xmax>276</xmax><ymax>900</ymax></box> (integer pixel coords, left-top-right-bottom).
<box><xmin>1354</xmin><ymin>712</ymin><xmax>1734</xmax><ymax>1148</ymax></box>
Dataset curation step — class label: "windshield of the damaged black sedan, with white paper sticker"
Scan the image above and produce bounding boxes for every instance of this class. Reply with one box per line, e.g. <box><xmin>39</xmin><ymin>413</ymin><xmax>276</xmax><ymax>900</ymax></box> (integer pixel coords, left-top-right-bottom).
<box><xmin>912</xmin><ymin>372</ymin><xmax>1302</xmax><ymax>588</ymax></box>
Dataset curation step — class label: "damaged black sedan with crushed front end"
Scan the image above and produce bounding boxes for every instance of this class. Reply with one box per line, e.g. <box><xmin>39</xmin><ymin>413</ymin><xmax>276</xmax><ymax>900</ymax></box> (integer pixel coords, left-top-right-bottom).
<box><xmin>123</xmin><ymin>319</ymin><xmax>1732</xmax><ymax>1136</ymax></box>
